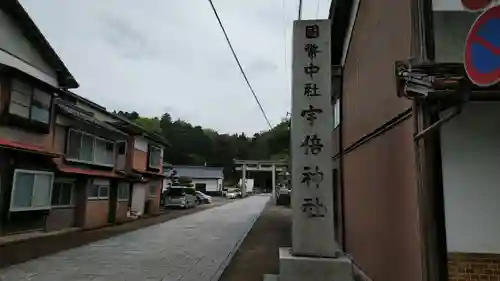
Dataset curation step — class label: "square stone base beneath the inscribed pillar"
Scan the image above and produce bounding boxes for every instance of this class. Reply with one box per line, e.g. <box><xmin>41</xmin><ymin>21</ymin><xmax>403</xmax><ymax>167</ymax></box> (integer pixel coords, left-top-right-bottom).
<box><xmin>264</xmin><ymin>248</ymin><xmax>354</xmax><ymax>281</ymax></box>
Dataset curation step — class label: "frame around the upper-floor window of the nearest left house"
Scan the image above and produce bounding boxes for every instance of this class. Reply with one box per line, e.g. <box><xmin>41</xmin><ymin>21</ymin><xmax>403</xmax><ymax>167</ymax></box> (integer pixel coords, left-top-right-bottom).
<box><xmin>6</xmin><ymin>76</ymin><xmax>54</xmax><ymax>123</ymax></box>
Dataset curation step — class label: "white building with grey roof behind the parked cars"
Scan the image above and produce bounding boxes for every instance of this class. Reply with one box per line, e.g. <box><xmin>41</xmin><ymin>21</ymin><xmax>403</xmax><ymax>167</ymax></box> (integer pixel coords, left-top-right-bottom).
<box><xmin>173</xmin><ymin>165</ymin><xmax>224</xmax><ymax>194</ymax></box>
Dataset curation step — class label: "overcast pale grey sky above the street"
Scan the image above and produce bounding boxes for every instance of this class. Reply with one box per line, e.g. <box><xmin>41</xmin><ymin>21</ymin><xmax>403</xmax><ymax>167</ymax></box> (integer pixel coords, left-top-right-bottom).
<box><xmin>20</xmin><ymin>0</ymin><xmax>330</xmax><ymax>134</ymax></box>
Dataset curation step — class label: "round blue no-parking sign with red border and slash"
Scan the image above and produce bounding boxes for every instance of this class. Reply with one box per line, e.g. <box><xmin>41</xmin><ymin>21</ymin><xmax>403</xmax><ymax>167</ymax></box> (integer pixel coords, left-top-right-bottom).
<box><xmin>464</xmin><ymin>6</ymin><xmax>500</xmax><ymax>86</ymax></box>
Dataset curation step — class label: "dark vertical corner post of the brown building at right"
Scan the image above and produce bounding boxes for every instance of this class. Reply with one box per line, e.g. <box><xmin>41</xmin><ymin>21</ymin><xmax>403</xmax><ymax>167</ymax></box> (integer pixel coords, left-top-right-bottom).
<box><xmin>411</xmin><ymin>0</ymin><xmax>450</xmax><ymax>281</ymax></box>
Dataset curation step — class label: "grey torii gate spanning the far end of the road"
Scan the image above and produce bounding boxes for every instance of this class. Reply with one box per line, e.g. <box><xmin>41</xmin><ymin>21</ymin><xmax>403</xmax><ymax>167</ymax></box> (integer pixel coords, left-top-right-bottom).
<box><xmin>234</xmin><ymin>159</ymin><xmax>288</xmax><ymax>198</ymax></box>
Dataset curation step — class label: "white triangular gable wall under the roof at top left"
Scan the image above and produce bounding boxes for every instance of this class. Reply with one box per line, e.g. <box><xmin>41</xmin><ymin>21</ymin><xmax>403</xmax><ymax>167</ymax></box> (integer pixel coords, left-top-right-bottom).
<box><xmin>0</xmin><ymin>10</ymin><xmax>58</xmax><ymax>87</ymax></box>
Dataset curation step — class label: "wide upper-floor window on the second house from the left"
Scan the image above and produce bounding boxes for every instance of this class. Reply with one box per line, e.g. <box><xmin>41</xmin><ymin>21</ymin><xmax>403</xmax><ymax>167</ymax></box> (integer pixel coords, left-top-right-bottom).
<box><xmin>66</xmin><ymin>129</ymin><xmax>115</xmax><ymax>167</ymax></box>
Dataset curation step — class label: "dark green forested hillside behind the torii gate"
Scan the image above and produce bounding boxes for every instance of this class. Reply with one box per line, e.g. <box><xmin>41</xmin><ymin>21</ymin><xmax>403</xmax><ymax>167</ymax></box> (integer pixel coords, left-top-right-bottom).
<box><xmin>111</xmin><ymin>108</ymin><xmax>290</xmax><ymax>180</ymax></box>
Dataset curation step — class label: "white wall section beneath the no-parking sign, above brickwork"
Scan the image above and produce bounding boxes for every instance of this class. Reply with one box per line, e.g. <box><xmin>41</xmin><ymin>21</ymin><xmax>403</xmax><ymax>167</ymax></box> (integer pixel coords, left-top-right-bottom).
<box><xmin>441</xmin><ymin>102</ymin><xmax>500</xmax><ymax>253</ymax></box>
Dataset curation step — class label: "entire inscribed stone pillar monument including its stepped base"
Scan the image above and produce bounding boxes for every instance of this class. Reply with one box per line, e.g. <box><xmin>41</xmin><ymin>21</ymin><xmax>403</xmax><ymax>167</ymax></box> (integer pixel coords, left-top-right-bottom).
<box><xmin>266</xmin><ymin>20</ymin><xmax>353</xmax><ymax>281</ymax></box>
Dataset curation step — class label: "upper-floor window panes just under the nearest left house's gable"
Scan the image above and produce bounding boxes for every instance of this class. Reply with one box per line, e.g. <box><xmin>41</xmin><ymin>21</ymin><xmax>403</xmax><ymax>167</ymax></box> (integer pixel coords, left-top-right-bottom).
<box><xmin>9</xmin><ymin>79</ymin><xmax>52</xmax><ymax>124</ymax></box>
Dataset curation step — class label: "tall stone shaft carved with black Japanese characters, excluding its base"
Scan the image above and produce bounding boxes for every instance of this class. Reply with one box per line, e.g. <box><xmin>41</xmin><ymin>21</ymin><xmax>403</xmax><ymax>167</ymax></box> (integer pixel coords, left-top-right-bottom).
<box><xmin>291</xmin><ymin>20</ymin><xmax>335</xmax><ymax>256</ymax></box>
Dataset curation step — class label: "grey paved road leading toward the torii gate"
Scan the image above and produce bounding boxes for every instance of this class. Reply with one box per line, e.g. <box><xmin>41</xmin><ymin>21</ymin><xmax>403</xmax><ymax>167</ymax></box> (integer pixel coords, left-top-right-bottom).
<box><xmin>0</xmin><ymin>196</ymin><xmax>269</xmax><ymax>281</ymax></box>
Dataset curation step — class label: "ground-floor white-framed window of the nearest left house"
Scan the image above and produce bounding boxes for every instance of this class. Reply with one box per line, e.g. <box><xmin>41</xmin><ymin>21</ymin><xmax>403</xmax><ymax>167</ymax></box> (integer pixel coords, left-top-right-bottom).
<box><xmin>10</xmin><ymin>169</ymin><xmax>54</xmax><ymax>212</ymax></box>
